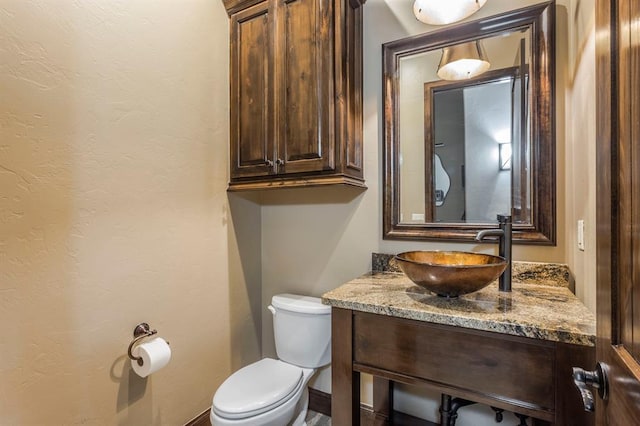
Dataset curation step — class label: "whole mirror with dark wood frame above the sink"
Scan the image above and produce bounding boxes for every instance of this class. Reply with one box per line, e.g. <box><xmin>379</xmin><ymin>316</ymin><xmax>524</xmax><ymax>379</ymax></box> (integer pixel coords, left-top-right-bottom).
<box><xmin>383</xmin><ymin>2</ymin><xmax>556</xmax><ymax>245</ymax></box>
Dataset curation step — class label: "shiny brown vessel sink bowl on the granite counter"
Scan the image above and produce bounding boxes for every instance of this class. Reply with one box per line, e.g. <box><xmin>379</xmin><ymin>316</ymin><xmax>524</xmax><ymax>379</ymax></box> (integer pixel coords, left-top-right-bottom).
<box><xmin>395</xmin><ymin>251</ymin><xmax>507</xmax><ymax>297</ymax></box>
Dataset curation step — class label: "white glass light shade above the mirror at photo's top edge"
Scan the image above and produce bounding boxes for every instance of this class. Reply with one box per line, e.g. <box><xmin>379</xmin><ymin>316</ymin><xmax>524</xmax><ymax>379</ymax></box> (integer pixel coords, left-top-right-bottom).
<box><xmin>413</xmin><ymin>0</ymin><xmax>487</xmax><ymax>25</ymax></box>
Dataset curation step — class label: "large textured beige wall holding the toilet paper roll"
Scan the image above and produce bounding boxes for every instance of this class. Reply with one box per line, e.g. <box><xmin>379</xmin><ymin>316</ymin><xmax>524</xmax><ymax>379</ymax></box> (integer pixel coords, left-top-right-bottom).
<box><xmin>0</xmin><ymin>0</ymin><xmax>261</xmax><ymax>425</ymax></box>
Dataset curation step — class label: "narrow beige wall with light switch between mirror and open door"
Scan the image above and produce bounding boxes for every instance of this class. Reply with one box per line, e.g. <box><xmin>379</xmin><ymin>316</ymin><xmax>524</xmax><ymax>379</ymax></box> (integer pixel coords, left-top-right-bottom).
<box><xmin>559</xmin><ymin>0</ymin><xmax>597</xmax><ymax>312</ymax></box>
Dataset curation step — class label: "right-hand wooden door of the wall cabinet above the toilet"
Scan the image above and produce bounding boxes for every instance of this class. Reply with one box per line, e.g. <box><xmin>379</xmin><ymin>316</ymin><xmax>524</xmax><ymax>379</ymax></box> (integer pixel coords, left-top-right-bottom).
<box><xmin>275</xmin><ymin>0</ymin><xmax>336</xmax><ymax>174</ymax></box>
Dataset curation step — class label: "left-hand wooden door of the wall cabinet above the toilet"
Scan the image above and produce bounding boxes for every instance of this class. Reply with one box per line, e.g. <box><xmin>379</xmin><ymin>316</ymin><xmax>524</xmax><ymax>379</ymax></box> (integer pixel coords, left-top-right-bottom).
<box><xmin>230</xmin><ymin>1</ymin><xmax>275</xmax><ymax>178</ymax></box>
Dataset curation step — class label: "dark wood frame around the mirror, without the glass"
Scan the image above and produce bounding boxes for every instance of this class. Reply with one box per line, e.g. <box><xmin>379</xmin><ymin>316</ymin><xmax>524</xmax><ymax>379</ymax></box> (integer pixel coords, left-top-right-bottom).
<box><xmin>382</xmin><ymin>1</ymin><xmax>556</xmax><ymax>245</ymax></box>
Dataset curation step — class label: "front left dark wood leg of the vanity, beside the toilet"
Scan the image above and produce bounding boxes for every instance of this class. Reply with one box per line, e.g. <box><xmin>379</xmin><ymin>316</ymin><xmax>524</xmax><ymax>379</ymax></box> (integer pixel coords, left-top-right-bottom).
<box><xmin>331</xmin><ymin>308</ymin><xmax>360</xmax><ymax>426</ymax></box>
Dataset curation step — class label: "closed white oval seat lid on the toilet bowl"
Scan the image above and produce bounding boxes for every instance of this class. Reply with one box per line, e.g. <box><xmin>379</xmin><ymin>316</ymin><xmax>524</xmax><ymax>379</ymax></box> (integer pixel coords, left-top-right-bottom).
<box><xmin>213</xmin><ymin>358</ymin><xmax>302</xmax><ymax>419</ymax></box>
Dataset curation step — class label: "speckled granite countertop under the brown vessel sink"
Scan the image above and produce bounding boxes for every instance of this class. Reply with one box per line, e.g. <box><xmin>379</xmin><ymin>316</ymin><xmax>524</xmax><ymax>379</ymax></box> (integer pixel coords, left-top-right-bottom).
<box><xmin>322</xmin><ymin>272</ymin><xmax>596</xmax><ymax>346</ymax></box>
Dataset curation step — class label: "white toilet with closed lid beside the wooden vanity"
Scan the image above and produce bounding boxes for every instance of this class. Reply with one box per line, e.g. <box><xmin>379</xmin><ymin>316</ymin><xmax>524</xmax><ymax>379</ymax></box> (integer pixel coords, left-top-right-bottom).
<box><xmin>211</xmin><ymin>294</ymin><xmax>331</xmax><ymax>426</ymax></box>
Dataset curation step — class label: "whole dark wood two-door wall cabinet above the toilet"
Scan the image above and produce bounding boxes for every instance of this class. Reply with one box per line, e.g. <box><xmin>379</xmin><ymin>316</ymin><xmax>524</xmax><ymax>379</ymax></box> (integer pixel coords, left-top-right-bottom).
<box><xmin>223</xmin><ymin>0</ymin><xmax>364</xmax><ymax>191</ymax></box>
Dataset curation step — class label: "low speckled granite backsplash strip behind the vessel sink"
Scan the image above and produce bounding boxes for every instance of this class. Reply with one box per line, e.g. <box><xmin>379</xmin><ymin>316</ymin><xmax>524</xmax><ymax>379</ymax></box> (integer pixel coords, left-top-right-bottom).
<box><xmin>371</xmin><ymin>253</ymin><xmax>574</xmax><ymax>291</ymax></box>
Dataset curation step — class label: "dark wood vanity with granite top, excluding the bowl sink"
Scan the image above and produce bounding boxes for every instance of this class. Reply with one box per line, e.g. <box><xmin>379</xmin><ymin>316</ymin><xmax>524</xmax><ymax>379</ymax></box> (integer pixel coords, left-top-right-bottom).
<box><xmin>323</xmin><ymin>274</ymin><xmax>595</xmax><ymax>426</ymax></box>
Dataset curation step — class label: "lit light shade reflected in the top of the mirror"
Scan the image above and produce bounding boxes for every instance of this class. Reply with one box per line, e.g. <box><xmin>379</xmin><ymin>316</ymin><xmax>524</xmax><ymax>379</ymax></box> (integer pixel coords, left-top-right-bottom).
<box><xmin>438</xmin><ymin>40</ymin><xmax>491</xmax><ymax>80</ymax></box>
